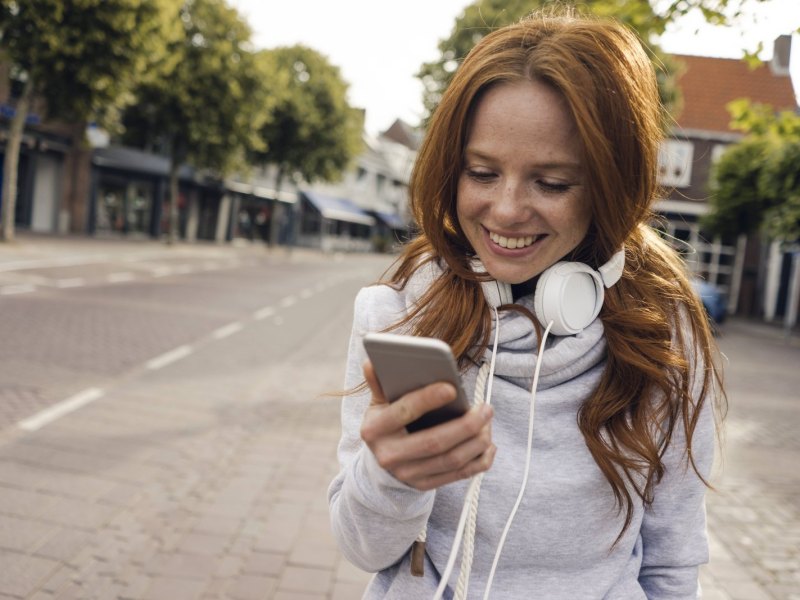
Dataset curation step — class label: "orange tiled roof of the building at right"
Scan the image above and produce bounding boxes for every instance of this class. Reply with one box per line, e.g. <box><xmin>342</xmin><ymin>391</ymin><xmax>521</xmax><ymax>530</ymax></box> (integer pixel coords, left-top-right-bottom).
<box><xmin>674</xmin><ymin>55</ymin><xmax>797</xmax><ymax>132</ymax></box>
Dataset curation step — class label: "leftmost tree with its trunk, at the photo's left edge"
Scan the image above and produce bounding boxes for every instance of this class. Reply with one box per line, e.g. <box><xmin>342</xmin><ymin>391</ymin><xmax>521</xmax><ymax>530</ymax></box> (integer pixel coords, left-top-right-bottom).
<box><xmin>0</xmin><ymin>0</ymin><xmax>177</xmax><ymax>241</ymax></box>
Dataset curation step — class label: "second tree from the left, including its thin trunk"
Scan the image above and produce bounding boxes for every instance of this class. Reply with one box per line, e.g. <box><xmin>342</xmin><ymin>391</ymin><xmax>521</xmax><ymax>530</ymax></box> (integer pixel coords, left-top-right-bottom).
<box><xmin>122</xmin><ymin>0</ymin><xmax>269</xmax><ymax>242</ymax></box>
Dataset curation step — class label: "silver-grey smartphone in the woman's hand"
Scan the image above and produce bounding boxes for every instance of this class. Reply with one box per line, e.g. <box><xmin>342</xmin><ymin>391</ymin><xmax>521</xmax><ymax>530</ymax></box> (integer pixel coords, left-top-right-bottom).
<box><xmin>364</xmin><ymin>333</ymin><xmax>469</xmax><ymax>432</ymax></box>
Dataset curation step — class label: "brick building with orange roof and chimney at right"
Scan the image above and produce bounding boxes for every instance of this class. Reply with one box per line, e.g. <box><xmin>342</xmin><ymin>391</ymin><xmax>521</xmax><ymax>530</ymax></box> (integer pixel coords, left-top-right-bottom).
<box><xmin>656</xmin><ymin>36</ymin><xmax>798</xmax><ymax>321</ymax></box>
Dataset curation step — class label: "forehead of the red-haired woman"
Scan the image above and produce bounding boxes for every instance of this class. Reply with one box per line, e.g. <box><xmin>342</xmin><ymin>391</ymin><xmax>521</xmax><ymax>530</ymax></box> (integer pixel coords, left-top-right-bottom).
<box><xmin>466</xmin><ymin>80</ymin><xmax>580</xmax><ymax>161</ymax></box>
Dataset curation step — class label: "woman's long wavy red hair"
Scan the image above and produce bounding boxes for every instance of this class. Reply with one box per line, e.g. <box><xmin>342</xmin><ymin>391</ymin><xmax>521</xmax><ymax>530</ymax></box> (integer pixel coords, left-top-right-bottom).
<box><xmin>385</xmin><ymin>11</ymin><xmax>725</xmax><ymax>535</ymax></box>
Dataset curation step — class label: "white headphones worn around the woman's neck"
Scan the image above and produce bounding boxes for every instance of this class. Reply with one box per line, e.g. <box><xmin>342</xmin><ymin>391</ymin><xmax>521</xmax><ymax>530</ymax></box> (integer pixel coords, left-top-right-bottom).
<box><xmin>471</xmin><ymin>248</ymin><xmax>625</xmax><ymax>335</ymax></box>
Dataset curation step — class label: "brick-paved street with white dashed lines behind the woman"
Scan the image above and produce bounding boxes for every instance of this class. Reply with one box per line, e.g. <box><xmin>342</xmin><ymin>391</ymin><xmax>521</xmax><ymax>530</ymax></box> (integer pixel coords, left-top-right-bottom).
<box><xmin>0</xmin><ymin>236</ymin><xmax>800</xmax><ymax>600</ymax></box>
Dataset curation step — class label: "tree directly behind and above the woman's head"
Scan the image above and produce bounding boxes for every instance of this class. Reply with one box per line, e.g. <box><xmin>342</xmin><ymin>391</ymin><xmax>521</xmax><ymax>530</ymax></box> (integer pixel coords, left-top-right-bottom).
<box><xmin>417</xmin><ymin>0</ymin><xmax>765</xmax><ymax>123</ymax></box>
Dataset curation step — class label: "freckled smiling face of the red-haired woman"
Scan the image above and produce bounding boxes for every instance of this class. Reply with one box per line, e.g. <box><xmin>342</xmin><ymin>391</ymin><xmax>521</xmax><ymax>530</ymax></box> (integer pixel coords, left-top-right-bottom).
<box><xmin>457</xmin><ymin>81</ymin><xmax>590</xmax><ymax>284</ymax></box>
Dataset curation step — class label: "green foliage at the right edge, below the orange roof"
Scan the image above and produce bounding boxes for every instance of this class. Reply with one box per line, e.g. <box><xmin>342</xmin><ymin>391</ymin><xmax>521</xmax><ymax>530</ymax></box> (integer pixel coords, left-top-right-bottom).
<box><xmin>703</xmin><ymin>100</ymin><xmax>800</xmax><ymax>242</ymax></box>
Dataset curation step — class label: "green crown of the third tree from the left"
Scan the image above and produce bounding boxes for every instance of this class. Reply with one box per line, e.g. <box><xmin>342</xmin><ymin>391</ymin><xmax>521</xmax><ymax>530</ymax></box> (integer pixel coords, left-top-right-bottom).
<box><xmin>253</xmin><ymin>45</ymin><xmax>363</xmax><ymax>182</ymax></box>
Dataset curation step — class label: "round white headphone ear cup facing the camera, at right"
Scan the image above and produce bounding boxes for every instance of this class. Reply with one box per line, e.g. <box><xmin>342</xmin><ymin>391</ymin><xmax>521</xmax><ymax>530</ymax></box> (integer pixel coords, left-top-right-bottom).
<box><xmin>533</xmin><ymin>262</ymin><xmax>604</xmax><ymax>335</ymax></box>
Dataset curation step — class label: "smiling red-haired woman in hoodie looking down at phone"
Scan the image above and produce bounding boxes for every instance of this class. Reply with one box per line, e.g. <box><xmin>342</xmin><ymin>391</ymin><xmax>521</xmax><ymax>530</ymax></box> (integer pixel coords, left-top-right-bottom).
<box><xmin>329</xmin><ymin>9</ymin><xmax>722</xmax><ymax>600</ymax></box>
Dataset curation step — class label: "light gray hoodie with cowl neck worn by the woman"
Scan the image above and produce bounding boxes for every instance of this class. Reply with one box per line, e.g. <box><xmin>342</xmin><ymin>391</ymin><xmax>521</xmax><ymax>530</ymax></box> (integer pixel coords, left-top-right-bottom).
<box><xmin>329</xmin><ymin>267</ymin><xmax>714</xmax><ymax>600</ymax></box>
